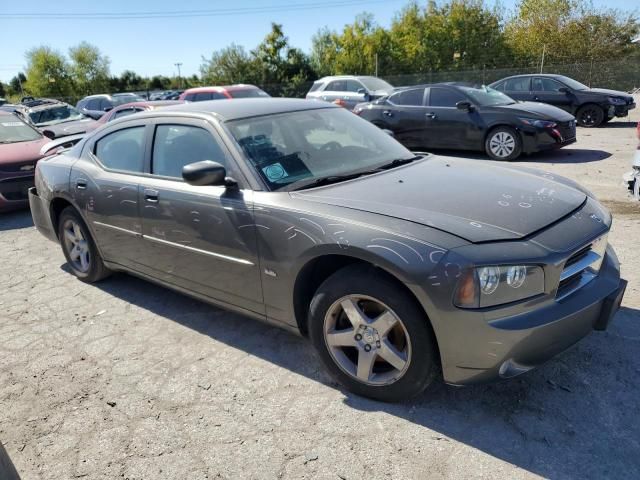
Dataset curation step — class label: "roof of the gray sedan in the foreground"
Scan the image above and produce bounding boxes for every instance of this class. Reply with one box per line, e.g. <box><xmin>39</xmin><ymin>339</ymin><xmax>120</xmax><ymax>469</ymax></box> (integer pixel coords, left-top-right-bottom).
<box><xmin>159</xmin><ymin>98</ymin><xmax>340</xmax><ymax>121</ymax></box>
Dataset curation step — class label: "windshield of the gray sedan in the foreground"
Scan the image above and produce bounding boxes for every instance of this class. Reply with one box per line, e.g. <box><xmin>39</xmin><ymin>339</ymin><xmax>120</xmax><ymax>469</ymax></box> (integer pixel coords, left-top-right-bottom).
<box><xmin>227</xmin><ymin>108</ymin><xmax>415</xmax><ymax>190</ymax></box>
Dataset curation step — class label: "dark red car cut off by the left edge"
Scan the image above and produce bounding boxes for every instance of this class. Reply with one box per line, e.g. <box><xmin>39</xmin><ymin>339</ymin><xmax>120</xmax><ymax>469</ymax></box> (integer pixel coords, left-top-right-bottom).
<box><xmin>0</xmin><ymin>111</ymin><xmax>51</xmax><ymax>212</ymax></box>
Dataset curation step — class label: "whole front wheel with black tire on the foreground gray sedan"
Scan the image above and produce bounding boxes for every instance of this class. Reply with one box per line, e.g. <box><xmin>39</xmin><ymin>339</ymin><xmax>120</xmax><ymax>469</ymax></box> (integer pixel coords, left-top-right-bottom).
<box><xmin>309</xmin><ymin>265</ymin><xmax>440</xmax><ymax>402</ymax></box>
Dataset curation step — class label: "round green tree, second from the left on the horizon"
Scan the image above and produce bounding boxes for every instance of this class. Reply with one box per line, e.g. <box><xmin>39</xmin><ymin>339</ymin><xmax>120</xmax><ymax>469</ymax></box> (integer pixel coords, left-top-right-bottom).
<box><xmin>69</xmin><ymin>42</ymin><xmax>110</xmax><ymax>96</ymax></box>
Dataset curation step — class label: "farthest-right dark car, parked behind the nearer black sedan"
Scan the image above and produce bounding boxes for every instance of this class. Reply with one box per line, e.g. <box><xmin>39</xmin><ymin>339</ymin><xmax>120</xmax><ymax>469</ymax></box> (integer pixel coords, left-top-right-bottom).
<box><xmin>490</xmin><ymin>74</ymin><xmax>636</xmax><ymax>127</ymax></box>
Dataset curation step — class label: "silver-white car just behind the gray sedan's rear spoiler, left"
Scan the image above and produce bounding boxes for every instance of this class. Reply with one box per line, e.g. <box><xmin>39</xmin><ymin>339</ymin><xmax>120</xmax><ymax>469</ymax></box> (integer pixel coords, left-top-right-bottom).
<box><xmin>25</xmin><ymin>101</ymin><xmax>95</xmax><ymax>138</ymax></box>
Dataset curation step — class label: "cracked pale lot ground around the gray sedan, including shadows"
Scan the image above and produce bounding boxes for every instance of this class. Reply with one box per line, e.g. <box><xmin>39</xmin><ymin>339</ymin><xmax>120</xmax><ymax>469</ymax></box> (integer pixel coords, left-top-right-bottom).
<box><xmin>0</xmin><ymin>105</ymin><xmax>640</xmax><ymax>480</ymax></box>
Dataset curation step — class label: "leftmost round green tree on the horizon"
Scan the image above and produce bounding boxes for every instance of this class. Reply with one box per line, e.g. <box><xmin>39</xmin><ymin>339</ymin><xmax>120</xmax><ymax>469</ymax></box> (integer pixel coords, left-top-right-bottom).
<box><xmin>23</xmin><ymin>46</ymin><xmax>73</xmax><ymax>98</ymax></box>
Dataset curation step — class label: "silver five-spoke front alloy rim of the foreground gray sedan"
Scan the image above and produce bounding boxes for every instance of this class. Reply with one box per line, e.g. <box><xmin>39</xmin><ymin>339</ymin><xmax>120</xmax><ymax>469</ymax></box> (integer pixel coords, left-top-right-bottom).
<box><xmin>324</xmin><ymin>295</ymin><xmax>411</xmax><ymax>385</ymax></box>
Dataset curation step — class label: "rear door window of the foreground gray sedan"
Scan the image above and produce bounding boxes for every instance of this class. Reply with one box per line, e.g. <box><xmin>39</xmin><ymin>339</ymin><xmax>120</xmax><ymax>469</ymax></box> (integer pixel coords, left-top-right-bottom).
<box><xmin>94</xmin><ymin>127</ymin><xmax>145</xmax><ymax>173</ymax></box>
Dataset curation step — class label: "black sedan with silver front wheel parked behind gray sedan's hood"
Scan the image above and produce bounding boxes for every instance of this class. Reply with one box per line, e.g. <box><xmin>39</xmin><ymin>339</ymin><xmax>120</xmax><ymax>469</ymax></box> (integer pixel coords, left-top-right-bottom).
<box><xmin>354</xmin><ymin>83</ymin><xmax>576</xmax><ymax>160</ymax></box>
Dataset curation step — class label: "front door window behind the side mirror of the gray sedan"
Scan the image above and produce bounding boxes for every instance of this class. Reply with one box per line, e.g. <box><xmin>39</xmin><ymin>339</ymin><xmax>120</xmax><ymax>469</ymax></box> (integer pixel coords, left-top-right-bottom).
<box><xmin>151</xmin><ymin>125</ymin><xmax>229</xmax><ymax>178</ymax></box>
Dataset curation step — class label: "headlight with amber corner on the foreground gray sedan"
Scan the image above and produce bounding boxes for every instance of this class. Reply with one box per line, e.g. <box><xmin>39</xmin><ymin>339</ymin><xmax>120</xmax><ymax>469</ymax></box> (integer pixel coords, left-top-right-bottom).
<box><xmin>454</xmin><ymin>265</ymin><xmax>544</xmax><ymax>308</ymax></box>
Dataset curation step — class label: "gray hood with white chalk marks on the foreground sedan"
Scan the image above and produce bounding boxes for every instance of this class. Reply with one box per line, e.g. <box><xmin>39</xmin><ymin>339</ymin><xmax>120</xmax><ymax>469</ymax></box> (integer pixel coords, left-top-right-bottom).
<box><xmin>291</xmin><ymin>157</ymin><xmax>586</xmax><ymax>243</ymax></box>
